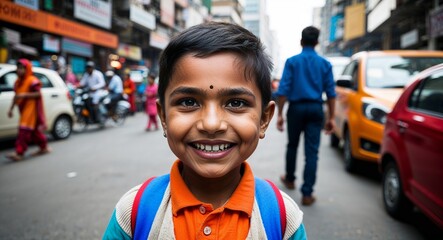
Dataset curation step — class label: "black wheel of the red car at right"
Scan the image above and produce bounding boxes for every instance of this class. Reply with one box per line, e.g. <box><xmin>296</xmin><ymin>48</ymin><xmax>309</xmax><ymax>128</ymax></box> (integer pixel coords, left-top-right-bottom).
<box><xmin>382</xmin><ymin>161</ymin><xmax>412</xmax><ymax>219</ymax></box>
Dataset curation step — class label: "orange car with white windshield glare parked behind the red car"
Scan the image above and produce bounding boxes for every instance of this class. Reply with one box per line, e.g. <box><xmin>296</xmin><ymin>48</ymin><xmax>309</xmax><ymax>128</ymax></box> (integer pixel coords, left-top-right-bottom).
<box><xmin>331</xmin><ymin>50</ymin><xmax>443</xmax><ymax>171</ymax></box>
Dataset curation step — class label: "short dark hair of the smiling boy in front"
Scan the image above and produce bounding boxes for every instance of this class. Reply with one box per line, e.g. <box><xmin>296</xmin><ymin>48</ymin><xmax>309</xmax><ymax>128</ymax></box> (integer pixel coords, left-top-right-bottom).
<box><xmin>158</xmin><ymin>22</ymin><xmax>273</xmax><ymax>107</ymax></box>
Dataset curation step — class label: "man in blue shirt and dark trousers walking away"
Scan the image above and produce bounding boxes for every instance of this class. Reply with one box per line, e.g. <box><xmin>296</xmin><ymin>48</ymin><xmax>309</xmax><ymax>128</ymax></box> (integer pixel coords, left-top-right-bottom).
<box><xmin>276</xmin><ymin>27</ymin><xmax>336</xmax><ymax>206</ymax></box>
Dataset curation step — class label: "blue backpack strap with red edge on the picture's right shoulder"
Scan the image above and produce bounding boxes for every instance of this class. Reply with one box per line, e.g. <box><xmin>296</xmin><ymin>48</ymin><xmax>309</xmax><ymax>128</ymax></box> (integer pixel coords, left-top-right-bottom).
<box><xmin>255</xmin><ymin>178</ymin><xmax>286</xmax><ymax>239</ymax></box>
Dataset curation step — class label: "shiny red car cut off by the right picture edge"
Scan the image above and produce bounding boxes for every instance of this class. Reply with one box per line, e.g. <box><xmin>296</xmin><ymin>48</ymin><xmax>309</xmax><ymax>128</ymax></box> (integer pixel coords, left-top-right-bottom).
<box><xmin>379</xmin><ymin>64</ymin><xmax>443</xmax><ymax>228</ymax></box>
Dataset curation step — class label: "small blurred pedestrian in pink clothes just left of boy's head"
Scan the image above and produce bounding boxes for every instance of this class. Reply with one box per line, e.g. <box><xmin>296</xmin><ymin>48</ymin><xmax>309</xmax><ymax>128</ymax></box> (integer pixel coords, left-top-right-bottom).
<box><xmin>145</xmin><ymin>74</ymin><xmax>158</xmax><ymax>131</ymax></box>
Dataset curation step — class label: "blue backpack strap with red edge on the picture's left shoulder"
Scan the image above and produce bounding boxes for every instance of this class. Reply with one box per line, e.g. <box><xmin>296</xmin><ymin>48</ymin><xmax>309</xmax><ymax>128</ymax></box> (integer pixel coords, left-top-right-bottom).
<box><xmin>131</xmin><ymin>174</ymin><xmax>169</xmax><ymax>240</ymax></box>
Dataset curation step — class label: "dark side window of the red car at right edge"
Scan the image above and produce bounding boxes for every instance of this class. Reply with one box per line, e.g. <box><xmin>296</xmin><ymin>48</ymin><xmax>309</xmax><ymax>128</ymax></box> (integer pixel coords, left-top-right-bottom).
<box><xmin>408</xmin><ymin>70</ymin><xmax>443</xmax><ymax>116</ymax></box>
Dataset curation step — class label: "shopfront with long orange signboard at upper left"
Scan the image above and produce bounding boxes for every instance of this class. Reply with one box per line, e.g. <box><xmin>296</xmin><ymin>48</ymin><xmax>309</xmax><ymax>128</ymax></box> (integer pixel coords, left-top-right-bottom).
<box><xmin>0</xmin><ymin>1</ymin><xmax>118</xmax><ymax>73</ymax></box>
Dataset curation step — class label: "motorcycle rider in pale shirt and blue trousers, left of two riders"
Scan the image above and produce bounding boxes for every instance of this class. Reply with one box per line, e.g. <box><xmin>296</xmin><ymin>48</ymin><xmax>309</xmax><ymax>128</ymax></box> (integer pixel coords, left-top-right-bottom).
<box><xmin>80</xmin><ymin>61</ymin><xmax>106</xmax><ymax>124</ymax></box>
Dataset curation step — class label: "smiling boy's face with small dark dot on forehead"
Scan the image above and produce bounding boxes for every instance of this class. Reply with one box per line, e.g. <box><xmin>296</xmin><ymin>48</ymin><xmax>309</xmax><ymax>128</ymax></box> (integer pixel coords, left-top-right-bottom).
<box><xmin>158</xmin><ymin>53</ymin><xmax>275</xmax><ymax>178</ymax></box>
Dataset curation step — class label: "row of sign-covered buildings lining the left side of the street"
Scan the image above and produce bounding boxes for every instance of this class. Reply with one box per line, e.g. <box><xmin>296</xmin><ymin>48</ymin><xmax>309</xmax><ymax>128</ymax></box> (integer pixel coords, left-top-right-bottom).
<box><xmin>0</xmin><ymin>0</ymin><xmax>210</xmax><ymax>78</ymax></box>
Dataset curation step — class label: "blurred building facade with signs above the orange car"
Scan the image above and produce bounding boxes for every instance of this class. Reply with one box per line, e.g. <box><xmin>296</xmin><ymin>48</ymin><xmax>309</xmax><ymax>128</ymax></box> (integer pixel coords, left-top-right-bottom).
<box><xmin>321</xmin><ymin>0</ymin><xmax>443</xmax><ymax>56</ymax></box>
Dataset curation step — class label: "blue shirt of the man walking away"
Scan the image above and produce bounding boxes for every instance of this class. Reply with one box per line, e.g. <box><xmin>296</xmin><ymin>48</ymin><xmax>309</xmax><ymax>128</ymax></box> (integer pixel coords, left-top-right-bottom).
<box><xmin>276</xmin><ymin>47</ymin><xmax>336</xmax><ymax>103</ymax></box>
